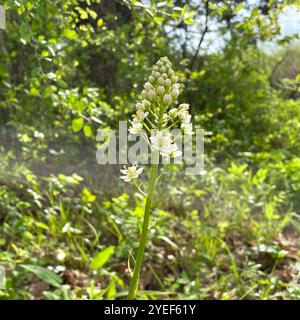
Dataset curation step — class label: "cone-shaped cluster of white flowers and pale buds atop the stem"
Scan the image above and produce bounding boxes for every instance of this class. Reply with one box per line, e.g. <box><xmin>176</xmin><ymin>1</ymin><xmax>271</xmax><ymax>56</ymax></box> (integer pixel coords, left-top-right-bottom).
<box><xmin>129</xmin><ymin>57</ymin><xmax>193</xmax><ymax>158</ymax></box>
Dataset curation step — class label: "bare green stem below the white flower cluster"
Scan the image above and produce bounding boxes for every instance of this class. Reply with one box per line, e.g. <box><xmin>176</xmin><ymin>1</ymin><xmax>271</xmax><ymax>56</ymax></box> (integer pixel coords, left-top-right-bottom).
<box><xmin>127</xmin><ymin>164</ymin><xmax>158</xmax><ymax>300</ymax></box>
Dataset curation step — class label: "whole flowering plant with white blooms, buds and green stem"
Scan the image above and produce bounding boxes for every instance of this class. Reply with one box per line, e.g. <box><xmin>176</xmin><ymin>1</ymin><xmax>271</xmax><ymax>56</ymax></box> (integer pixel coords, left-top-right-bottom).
<box><xmin>125</xmin><ymin>57</ymin><xmax>199</xmax><ymax>299</ymax></box>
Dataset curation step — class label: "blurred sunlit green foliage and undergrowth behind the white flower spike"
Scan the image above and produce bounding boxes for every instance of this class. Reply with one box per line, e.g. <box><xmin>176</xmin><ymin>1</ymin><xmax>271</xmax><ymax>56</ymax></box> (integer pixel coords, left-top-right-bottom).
<box><xmin>0</xmin><ymin>0</ymin><xmax>300</xmax><ymax>299</ymax></box>
